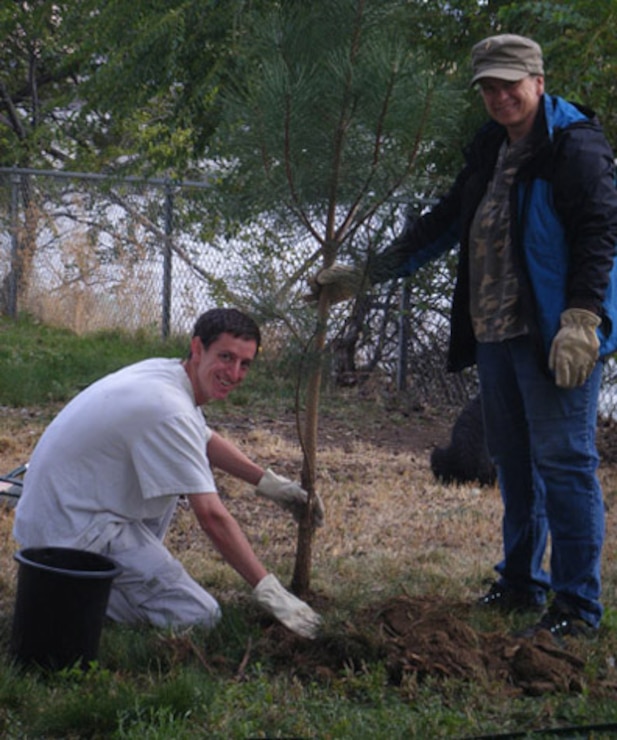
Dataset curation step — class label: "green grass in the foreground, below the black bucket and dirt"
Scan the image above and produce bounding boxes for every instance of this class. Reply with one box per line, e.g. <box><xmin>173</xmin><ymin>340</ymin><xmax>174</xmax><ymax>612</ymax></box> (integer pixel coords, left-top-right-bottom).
<box><xmin>0</xmin><ymin>606</ymin><xmax>466</xmax><ymax>738</ymax></box>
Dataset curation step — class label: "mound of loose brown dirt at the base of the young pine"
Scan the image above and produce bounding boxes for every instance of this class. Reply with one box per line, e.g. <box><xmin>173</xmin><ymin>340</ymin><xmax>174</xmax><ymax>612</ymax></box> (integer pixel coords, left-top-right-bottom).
<box><xmin>266</xmin><ymin>596</ymin><xmax>585</xmax><ymax>696</ymax></box>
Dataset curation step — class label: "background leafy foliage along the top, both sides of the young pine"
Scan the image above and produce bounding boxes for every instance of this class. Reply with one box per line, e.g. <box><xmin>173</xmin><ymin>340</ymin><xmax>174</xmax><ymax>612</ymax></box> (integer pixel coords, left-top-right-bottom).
<box><xmin>0</xmin><ymin>0</ymin><xmax>617</xmax><ymax>172</ymax></box>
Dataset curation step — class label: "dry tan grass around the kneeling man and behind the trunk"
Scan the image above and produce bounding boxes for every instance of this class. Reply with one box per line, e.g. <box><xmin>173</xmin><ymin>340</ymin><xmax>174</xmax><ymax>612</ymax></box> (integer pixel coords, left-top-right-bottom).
<box><xmin>0</xmin><ymin>398</ymin><xmax>617</xmax><ymax>620</ymax></box>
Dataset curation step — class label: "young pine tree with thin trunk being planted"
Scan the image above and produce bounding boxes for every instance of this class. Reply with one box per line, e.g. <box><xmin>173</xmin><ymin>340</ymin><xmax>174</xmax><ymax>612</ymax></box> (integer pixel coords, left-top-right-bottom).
<box><xmin>217</xmin><ymin>0</ymin><xmax>462</xmax><ymax>594</ymax></box>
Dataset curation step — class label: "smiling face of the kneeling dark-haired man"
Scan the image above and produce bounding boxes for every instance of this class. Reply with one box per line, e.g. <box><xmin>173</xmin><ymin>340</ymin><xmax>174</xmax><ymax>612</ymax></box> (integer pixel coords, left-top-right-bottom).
<box><xmin>187</xmin><ymin>334</ymin><xmax>257</xmax><ymax>406</ymax></box>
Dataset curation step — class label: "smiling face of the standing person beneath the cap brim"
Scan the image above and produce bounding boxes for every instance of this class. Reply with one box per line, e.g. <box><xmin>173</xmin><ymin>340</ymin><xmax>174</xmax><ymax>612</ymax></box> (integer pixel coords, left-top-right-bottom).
<box><xmin>479</xmin><ymin>76</ymin><xmax>544</xmax><ymax>141</ymax></box>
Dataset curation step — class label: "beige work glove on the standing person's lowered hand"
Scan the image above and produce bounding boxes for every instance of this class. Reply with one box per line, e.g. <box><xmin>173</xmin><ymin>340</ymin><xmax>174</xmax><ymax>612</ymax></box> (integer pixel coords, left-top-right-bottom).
<box><xmin>548</xmin><ymin>308</ymin><xmax>600</xmax><ymax>388</ymax></box>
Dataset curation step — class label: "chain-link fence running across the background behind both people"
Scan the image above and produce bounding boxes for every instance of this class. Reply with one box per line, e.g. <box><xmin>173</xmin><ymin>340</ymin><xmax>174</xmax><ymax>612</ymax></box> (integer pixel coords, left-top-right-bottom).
<box><xmin>0</xmin><ymin>168</ymin><xmax>617</xmax><ymax>418</ymax></box>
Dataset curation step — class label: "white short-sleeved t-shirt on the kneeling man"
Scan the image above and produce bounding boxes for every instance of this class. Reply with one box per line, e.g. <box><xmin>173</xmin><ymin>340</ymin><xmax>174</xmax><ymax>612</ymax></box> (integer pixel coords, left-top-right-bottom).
<box><xmin>13</xmin><ymin>358</ymin><xmax>216</xmax><ymax>549</ymax></box>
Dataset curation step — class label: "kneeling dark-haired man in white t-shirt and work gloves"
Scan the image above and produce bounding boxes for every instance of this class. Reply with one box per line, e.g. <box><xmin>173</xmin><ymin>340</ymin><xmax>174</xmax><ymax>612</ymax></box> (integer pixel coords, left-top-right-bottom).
<box><xmin>14</xmin><ymin>308</ymin><xmax>323</xmax><ymax>637</ymax></box>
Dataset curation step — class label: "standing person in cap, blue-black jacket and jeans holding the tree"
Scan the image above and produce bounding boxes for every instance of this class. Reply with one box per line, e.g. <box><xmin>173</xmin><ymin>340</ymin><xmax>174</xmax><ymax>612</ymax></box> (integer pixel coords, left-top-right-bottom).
<box><xmin>312</xmin><ymin>34</ymin><xmax>617</xmax><ymax>636</ymax></box>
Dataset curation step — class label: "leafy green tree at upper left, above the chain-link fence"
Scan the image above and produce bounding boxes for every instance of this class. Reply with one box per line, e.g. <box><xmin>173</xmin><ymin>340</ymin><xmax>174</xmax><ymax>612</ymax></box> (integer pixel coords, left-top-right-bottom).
<box><xmin>0</xmin><ymin>0</ymin><xmax>274</xmax><ymax>314</ymax></box>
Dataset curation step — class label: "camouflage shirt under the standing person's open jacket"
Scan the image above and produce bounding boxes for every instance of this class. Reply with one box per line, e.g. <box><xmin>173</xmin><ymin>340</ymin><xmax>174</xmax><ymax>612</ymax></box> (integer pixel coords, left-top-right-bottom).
<box><xmin>469</xmin><ymin>139</ymin><xmax>530</xmax><ymax>342</ymax></box>
